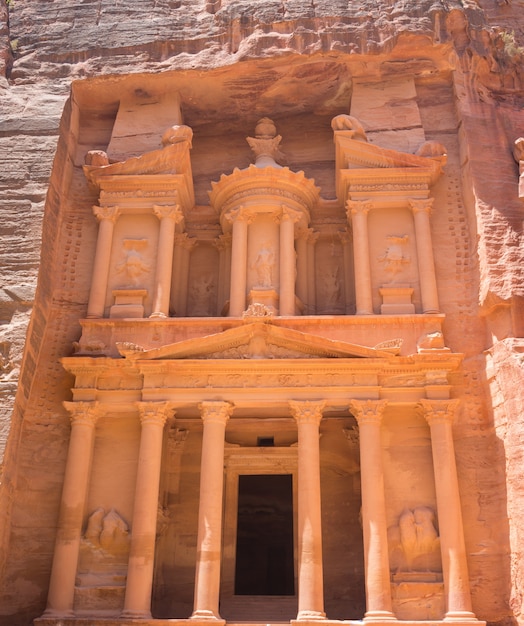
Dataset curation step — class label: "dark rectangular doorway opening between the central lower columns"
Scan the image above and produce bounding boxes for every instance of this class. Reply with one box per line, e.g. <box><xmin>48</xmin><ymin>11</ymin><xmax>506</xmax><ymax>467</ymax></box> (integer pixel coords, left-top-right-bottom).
<box><xmin>235</xmin><ymin>474</ymin><xmax>295</xmax><ymax>596</ymax></box>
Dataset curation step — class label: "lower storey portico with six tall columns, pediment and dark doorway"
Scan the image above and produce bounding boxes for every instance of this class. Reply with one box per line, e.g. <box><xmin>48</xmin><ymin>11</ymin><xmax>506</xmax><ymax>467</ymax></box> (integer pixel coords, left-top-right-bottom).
<box><xmin>35</xmin><ymin>314</ymin><xmax>479</xmax><ymax>626</ymax></box>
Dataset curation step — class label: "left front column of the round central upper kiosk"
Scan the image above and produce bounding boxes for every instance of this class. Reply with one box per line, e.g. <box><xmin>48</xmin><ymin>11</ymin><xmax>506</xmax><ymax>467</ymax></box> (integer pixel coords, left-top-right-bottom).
<box><xmin>226</xmin><ymin>207</ymin><xmax>253</xmax><ymax>317</ymax></box>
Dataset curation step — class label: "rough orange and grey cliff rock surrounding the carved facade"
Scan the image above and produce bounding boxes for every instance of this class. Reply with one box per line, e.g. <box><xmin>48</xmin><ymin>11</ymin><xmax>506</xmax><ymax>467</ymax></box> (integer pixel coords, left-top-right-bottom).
<box><xmin>0</xmin><ymin>0</ymin><xmax>524</xmax><ymax>626</ymax></box>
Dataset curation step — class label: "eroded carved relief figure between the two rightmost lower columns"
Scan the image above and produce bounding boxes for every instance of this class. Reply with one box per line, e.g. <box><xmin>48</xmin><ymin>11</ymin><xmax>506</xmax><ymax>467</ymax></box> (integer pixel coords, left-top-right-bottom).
<box><xmin>388</xmin><ymin>506</ymin><xmax>442</xmax><ymax>572</ymax></box>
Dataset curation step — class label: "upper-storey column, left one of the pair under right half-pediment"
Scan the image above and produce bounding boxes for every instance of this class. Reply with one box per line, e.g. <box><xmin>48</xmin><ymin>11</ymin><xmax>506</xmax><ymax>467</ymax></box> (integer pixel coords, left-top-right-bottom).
<box><xmin>346</xmin><ymin>200</ymin><xmax>373</xmax><ymax>315</ymax></box>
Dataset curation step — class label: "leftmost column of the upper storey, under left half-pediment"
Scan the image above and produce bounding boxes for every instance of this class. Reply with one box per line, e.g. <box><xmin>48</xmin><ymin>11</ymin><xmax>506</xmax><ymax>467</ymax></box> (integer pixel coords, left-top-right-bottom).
<box><xmin>87</xmin><ymin>206</ymin><xmax>120</xmax><ymax>318</ymax></box>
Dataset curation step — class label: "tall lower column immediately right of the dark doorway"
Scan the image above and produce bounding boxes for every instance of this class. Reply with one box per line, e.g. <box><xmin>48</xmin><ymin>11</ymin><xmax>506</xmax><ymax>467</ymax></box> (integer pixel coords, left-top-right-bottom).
<box><xmin>289</xmin><ymin>402</ymin><xmax>326</xmax><ymax>621</ymax></box>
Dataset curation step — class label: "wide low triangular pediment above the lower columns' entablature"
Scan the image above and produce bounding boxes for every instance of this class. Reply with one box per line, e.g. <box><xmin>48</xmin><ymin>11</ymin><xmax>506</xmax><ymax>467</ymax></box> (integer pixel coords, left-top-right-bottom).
<box><xmin>117</xmin><ymin>322</ymin><xmax>393</xmax><ymax>360</ymax></box>
